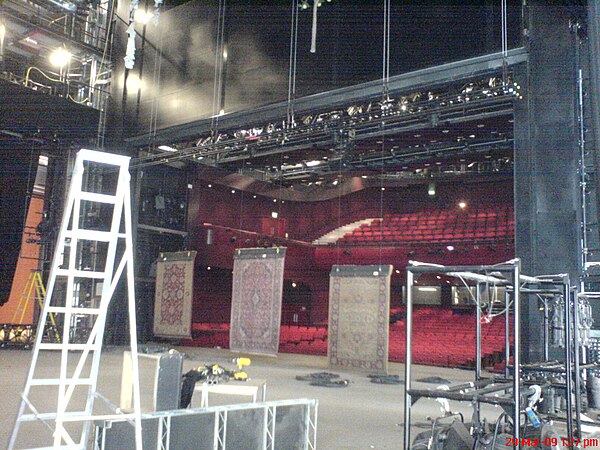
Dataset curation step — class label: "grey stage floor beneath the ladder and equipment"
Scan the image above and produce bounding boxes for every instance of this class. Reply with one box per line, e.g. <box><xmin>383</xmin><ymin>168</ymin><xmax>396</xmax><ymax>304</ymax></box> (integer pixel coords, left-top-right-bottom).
<box><xmin>0</xmin><ymin>347</ymin><xmax>500</xmax><ymax>449</ymax></box>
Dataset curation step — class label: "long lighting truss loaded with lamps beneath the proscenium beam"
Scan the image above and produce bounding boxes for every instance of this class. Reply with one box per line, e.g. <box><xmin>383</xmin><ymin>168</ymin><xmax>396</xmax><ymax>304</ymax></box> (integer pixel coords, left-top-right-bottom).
<box><xmin>132</xmin><ymin>77</ymin><xmax>523</xmax><ymax>174</ymax></box>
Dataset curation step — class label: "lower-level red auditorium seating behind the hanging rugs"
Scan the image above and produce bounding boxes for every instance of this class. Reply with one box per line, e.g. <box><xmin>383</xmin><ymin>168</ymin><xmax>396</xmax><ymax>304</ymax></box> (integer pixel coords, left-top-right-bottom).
<box><xmin>184</xmin><ymin>306</ymin><xmax>512</xmax><ymax>367</ymax></box>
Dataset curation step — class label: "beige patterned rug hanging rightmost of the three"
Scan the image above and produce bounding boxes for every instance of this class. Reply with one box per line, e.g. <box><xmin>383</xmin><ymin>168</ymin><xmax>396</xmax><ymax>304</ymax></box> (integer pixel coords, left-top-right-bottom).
<box><xmin>327</xmin><ymin>265</ymin><xmax>393</xmax><ymax>374</ymax></box>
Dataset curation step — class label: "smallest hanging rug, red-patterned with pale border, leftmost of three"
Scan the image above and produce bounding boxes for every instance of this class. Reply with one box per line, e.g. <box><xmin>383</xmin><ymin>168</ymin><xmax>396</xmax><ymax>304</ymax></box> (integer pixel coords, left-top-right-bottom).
<box><xmin>154</xmin><ymin>252</ymin><xmax>196</xmax><ymax>338</ymax></box>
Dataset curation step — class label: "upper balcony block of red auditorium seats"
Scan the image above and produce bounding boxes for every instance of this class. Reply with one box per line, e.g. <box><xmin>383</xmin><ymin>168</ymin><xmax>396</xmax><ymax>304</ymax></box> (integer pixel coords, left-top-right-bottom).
<box><xmin>338</xmin><ymin>205</ymin><xmax>514</xmax><ymax>245</ymax></box>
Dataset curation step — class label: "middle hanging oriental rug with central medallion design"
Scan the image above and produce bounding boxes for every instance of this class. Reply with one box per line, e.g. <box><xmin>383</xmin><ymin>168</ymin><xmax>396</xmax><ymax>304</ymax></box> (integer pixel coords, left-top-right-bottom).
<box><xmin>229</xmin><ymin>247</ymin><xmax>286</xmax><ymax>355</ymax></box>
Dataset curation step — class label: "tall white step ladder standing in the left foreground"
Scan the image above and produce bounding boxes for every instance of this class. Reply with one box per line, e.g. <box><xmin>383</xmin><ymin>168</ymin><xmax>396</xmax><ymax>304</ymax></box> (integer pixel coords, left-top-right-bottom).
<box><xmin>8</xmin><ymin>150</ymin><xmax>142</xmax><ymax>450</ymax></box>
